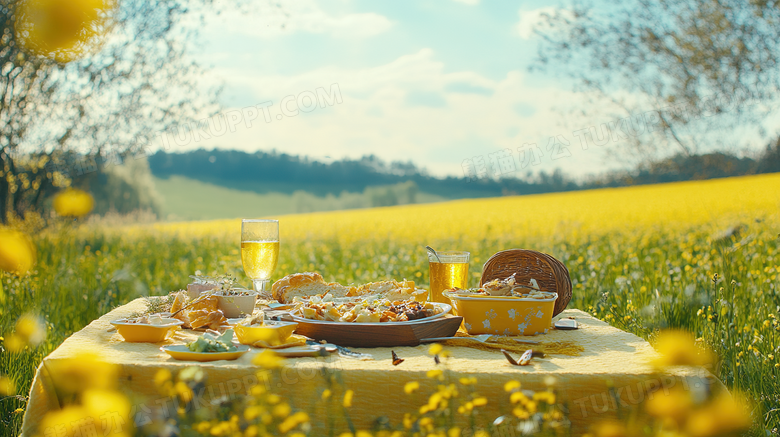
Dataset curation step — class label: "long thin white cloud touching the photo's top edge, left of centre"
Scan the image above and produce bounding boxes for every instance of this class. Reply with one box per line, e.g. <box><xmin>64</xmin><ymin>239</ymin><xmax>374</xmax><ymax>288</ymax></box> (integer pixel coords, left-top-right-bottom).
<box><xmin>214</xmin><ymin>0</ymin><xmax>394</xmax><ymax>38</ymax></box>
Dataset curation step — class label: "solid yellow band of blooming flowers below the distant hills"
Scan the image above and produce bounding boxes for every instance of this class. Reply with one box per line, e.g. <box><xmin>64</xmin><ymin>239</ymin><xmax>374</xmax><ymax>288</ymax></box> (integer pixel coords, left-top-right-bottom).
<box><xmin>128</xmin><ymin>174</ymin><xmax>780</xmax><ymax>244</ymax></box>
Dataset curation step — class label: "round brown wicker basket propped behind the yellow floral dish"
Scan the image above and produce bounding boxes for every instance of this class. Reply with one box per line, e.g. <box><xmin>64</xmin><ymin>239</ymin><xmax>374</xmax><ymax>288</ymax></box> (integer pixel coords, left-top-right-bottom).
<box><xmin>479</xmin><ymin>249</ymin><xmax>571</xmax><ymax>316</ymax></box>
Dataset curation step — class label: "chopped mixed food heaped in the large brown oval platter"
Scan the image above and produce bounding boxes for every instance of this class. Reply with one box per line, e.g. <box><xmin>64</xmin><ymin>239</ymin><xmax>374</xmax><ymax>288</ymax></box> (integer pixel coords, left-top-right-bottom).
<box><xmin>293</xmin><ymin>293</ymin><xmax>443</xmax><ymax>323</ymax></box>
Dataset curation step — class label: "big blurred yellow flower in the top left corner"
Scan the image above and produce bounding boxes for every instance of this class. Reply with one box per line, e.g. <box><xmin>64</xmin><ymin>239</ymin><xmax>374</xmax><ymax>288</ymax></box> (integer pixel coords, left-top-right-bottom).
<box><xmin>16</xmin><ymin>0</ymin><xmax>114</xmax><ymax>62</ymax></box>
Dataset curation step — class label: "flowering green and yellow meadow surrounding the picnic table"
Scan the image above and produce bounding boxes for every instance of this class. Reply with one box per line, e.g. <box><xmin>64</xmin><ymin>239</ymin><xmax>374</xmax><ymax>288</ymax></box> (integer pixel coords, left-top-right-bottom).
<box><xmin>0</xmin><ymin>175</ymin><xmax>780</xmax><ymax>435</ymax></box>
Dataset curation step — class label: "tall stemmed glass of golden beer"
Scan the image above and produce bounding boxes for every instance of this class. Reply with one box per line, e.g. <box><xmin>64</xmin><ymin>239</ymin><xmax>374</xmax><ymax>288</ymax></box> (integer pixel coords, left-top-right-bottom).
<box><xmin>241</xmin><ymin>219</ymin><xmax>279</xmax><ymax>292</ymax></box>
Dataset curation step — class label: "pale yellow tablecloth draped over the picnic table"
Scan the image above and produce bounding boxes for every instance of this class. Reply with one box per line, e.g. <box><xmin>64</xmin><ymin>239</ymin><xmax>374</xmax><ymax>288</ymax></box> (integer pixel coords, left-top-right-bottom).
<box><xmin>23</xmin><ymin>299</ymin><xmax>720</xmax><ymax>436</ymax></box>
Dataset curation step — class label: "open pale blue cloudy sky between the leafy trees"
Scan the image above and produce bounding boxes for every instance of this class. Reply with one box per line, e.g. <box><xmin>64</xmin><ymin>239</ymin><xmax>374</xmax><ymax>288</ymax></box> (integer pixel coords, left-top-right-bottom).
<box><xmin>174</xmin><ymin>0</ymin><xmax>640</xmax><ymax>176</ymax></box>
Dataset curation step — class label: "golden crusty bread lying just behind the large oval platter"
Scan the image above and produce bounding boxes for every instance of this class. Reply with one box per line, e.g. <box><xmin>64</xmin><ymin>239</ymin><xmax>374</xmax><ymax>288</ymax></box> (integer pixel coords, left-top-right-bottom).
<box><xmin>271</xmin><ymin>272</ymin><xmax>427</xmax><ymax>304</ymax></box>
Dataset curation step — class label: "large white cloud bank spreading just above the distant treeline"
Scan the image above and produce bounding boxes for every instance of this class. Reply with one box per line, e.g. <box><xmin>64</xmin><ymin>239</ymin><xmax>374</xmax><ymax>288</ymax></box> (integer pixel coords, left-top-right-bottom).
<box><xmin>186</xmin><ymin>49</ymin><xmax>603</xmax><ymax>175</ymax></box>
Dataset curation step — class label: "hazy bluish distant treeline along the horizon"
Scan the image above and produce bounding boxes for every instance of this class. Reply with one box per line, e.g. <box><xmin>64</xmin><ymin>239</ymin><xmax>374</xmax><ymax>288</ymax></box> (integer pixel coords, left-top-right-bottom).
<box><xmin>149</xmin><ymin>140</ymin><xmax>780</xmax><ymax>199</ymax></box>
